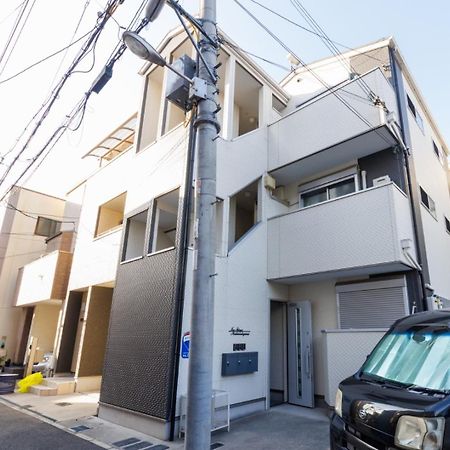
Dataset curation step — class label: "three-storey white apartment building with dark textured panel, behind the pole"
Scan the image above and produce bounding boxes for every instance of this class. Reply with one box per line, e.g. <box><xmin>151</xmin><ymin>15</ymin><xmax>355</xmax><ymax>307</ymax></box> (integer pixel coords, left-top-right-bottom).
<box><xmin>41</xmin><ymin>30</ymin><xmax>450</xmax><ymax>439</ymax></box>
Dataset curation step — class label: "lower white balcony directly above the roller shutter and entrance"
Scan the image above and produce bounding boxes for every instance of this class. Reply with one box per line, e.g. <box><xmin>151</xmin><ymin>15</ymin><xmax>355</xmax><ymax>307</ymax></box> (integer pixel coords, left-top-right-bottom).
<box><xmin>268</xmin><ymin>183</ymin><xmax>415</xmax><ymax>284</ymax></box>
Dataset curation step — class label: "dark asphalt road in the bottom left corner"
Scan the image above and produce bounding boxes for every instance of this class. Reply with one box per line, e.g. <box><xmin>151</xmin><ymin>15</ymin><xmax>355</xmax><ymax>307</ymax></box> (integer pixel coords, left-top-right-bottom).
<box><xmin>0</xmin><ymin>404</ymin><xmax>100</xmax><ymax>450</ymax></box>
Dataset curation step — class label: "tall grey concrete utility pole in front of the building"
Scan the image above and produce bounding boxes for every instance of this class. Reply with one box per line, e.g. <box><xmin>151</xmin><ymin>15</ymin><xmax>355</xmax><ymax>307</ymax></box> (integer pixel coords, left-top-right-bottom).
<box><xmin>185</xmin><ymin>0</ymin><xmax>219</xmax><ymax>450</ymax></box>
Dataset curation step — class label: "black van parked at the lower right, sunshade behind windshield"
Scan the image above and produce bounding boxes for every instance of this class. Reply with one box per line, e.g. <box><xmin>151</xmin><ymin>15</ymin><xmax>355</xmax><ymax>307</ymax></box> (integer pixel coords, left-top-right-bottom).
<box><xmin>330</xmin><ymin>310</ymin><xmax>450</xmax><ymax>450</ymax></box>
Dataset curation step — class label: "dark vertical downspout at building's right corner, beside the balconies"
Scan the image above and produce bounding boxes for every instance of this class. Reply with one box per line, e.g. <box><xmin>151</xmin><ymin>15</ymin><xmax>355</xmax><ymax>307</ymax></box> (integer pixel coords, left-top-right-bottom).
<box><xmin>389</xmin><ymin>47</ymin><xmax>428</xmax><ymax>311</ymax></box>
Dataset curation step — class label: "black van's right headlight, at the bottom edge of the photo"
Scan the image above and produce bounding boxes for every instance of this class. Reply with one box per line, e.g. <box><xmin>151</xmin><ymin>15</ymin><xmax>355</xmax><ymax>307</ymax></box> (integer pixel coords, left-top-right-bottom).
<box><xmin>395</xmin><ymin>416</ymin><xmax>445</xmax><ymax>450</ymax></box>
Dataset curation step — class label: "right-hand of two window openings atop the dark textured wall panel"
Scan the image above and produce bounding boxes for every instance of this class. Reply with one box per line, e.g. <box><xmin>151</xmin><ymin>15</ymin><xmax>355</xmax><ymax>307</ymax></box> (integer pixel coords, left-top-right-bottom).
<box><xmin>149</xmin><ymin>189</ymin><xmax>180</xmax><ymax>253</ymax></box>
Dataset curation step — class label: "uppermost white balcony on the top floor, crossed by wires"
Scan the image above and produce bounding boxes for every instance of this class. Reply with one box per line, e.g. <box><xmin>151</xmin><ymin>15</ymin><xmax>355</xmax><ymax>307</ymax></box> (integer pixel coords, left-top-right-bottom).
<box><xmin>268</xmin><ymin>69</ymin><xmax>397</xmax><ymax>185</ymax></box>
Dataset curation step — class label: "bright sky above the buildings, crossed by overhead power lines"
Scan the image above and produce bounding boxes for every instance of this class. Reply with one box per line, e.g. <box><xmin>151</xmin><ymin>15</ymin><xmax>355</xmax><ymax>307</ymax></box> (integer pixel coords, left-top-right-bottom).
<box><xmin>0</xmin><ymin>0</ymin><xmax>450</xmax><ymax>196</ymax></box>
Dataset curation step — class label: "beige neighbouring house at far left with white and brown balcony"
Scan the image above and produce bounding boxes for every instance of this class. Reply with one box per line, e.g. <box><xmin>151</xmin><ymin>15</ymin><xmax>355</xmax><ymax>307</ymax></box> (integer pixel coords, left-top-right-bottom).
<box><xmin>0</xmin><ymin>187</ymin><xmax>69</xmax><ymax>364</ymax></box>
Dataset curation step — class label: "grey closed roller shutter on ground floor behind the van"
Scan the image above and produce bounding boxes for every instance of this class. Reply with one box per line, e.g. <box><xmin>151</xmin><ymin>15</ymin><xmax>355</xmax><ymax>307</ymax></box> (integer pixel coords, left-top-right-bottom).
<box><xmin>336</xmin><ymin>282</ymin><xmax>407</xmax><ymax>329</ymax></box>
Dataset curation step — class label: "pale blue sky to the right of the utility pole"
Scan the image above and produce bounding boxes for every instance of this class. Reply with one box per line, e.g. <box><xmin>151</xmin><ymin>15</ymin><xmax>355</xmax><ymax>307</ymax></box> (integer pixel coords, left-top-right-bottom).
<box><xmin>218</xmin><ymin>0</ymin><xmax>450</xmax><ymax>144</ymax></box>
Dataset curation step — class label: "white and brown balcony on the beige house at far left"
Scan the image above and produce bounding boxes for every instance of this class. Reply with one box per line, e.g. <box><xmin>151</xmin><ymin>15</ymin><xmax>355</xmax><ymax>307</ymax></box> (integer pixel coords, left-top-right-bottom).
<box><xmin>16</xmin><ymin>250</ymin><xmax>72</xmax><ymax>306</ymax></box>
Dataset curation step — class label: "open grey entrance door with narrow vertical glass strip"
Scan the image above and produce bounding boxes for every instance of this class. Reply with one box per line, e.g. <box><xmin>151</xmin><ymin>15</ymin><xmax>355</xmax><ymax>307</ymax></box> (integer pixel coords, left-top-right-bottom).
<box><xmin>288</xmin><ymin>301</ymin><xmax>314</xmax><ymax>408</ymax></box>
